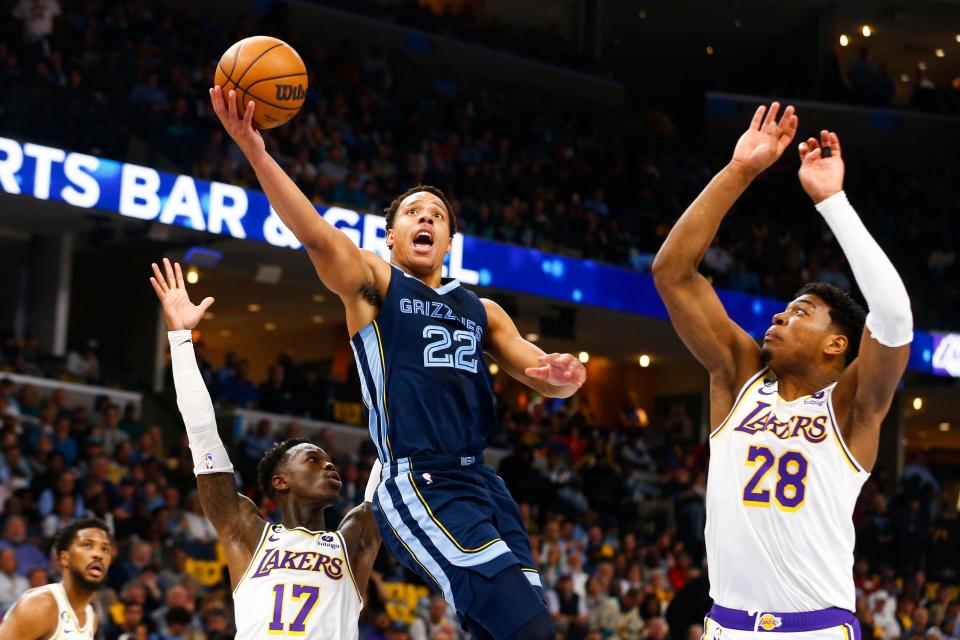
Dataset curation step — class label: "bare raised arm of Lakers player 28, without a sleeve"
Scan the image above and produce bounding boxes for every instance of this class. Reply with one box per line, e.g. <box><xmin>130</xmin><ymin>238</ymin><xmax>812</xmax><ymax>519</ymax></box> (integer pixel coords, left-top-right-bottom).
<box><xmin>653</xmin><ymin>102</ymin><xmax>797</xmax><ymax>416</ymax></box>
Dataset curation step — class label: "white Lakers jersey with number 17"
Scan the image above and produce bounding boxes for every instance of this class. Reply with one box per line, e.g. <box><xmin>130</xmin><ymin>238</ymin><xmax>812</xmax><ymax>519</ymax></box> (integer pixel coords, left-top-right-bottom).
<box><xmin>233</xmin><ymin>524</ymin><xmax>363</xmax><ymax>640</ymax></box>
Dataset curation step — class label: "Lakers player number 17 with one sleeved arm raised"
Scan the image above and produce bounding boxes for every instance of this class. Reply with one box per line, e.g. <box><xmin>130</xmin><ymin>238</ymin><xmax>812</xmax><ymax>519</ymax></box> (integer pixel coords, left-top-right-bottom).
<box><xmin>150</xmin><ymin>259</ymin><xmax>381</xmax><ymax>640</ymax></box>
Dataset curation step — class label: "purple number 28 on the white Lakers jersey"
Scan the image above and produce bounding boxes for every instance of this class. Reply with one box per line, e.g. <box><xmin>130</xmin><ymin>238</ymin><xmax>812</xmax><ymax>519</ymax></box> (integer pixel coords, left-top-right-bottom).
<box><xmin>743</xmin><ymin>445</ymin><xmax>808</xmax><ymax>511</ymax></box>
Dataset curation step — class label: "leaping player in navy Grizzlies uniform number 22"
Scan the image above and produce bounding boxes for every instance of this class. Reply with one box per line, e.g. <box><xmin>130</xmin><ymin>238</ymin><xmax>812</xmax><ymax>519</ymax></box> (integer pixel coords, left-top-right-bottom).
<box><xmin>211</xmin><ymin>87</ymin><xmax>586</xmax><ymax>640</ymax></box>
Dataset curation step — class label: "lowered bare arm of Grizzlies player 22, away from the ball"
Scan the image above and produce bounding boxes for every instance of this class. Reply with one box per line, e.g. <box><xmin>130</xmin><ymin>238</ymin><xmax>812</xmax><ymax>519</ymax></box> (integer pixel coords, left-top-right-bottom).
<box><xmin>481</xmin><ymin>298</ymin><xmax>587</xmax><ymax>398</ymax></box>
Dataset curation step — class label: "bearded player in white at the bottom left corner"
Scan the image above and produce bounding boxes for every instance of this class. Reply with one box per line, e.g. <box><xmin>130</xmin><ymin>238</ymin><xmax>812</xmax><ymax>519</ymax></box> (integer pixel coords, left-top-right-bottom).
<box><xmin>0</xmin><ymin>518</ymin><xmax>113</xmax><ymax>640</ymax></box>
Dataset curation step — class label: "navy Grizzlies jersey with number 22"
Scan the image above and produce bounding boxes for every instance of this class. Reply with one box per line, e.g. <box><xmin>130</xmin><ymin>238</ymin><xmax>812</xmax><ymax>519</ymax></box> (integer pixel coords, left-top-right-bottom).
<box><xmin>350</xmin><ymin>265</ymin><xmax>496</xmax><ymax>462</ymax></box>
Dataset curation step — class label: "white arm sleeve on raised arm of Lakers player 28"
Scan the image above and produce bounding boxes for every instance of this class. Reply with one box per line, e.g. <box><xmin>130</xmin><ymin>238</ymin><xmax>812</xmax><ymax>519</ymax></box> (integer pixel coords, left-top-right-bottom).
<box><xmin>817</xmin><ymin>191</ymin><xmax>913</xmax><ymax>347</ymax></box>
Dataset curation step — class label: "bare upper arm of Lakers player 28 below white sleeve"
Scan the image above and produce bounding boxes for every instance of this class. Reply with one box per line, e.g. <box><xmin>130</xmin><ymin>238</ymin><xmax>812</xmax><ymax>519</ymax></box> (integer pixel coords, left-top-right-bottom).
<box><xmin>833</xmin><ymin>328</ymin><xmax>910</xmax><ymax>471</ymax></box>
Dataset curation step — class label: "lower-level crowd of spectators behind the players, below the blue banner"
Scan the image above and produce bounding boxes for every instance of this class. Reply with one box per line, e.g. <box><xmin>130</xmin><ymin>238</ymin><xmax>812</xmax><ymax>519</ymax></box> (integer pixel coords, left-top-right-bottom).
<box><xmin>0</xmin><ymin>370</ymin><xmax>960</xmax><ymax>640</ymax></box>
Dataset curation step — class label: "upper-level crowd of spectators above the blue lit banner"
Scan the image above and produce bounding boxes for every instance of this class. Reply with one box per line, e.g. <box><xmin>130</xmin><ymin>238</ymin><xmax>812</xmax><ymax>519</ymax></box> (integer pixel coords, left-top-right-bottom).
<box><xmin>0</xmin><ymin>0</ymin><xmax>960</xmax><ymax>328</ymax></box>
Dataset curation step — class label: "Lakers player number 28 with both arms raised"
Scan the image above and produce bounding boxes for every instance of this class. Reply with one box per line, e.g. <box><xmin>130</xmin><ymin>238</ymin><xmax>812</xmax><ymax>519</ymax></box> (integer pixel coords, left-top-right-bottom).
<box><xmin>653</xmin><ymin>102</ymin><xmax>913</xmax><ymax>640</ymax></box>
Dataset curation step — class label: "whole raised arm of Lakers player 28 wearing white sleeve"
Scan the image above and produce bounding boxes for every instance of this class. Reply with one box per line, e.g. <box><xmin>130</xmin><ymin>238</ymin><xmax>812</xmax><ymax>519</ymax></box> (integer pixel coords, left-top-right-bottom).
<box><xmin>799</xmin><ymin>131</ymin><xmax>913</xmax><ymax>469</ymax></box>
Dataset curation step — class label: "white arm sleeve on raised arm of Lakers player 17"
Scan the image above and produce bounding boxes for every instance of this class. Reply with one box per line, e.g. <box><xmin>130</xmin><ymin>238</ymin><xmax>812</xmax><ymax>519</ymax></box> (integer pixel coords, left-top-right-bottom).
<box><xmin>167</xmin><ymin>329</ymin><xmax>233</xmax><ymax>475</ymax></box>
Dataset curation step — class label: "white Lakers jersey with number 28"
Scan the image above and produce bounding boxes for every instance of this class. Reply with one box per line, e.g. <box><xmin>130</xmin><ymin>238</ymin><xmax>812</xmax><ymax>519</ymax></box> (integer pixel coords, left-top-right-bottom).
<box><xmin>705</xmin><ymin>369</ymin><xmax>869</xmax><ymax>613</ymax></box>
